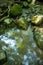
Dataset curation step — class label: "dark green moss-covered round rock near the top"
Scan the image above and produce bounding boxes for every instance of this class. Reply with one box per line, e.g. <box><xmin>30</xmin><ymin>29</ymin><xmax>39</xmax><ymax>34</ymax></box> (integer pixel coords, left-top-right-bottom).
<box><xmin>10</xmin><ymin>4</ymin><xmax>22</xmax><ymax>16</ymax></box>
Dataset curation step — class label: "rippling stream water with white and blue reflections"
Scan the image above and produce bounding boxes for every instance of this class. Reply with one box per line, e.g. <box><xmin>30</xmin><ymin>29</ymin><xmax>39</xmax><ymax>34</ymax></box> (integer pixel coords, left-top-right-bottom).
<box><xmin>0</xmin><ymin>27</ymin><xmax>43</xmax><ymax>65</ymax></box>
